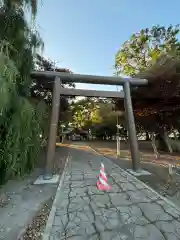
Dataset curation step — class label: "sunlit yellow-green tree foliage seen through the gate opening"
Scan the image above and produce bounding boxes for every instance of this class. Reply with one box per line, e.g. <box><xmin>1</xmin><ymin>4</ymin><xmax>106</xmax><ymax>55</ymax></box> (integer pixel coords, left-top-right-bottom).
<box><xmin>68</xmin><ymin>98</ymin><xmax>120</xmax><ymax>139</ymax></box>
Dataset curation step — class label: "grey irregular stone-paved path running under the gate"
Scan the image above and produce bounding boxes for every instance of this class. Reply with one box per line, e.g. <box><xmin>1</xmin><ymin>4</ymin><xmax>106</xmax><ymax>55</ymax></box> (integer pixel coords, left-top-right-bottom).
<box><xmin>46</xmin><ymin>143</ymin><xmax>180</xmax><ymax>240</ymax></box>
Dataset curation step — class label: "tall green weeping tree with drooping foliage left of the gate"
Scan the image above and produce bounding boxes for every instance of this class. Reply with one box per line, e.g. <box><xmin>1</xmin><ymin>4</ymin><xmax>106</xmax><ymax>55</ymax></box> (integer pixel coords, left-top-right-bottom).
<box><xmin>0</xmin><ymin>0</ymin><xmax>48</xmax><ymax>182</ymax></box>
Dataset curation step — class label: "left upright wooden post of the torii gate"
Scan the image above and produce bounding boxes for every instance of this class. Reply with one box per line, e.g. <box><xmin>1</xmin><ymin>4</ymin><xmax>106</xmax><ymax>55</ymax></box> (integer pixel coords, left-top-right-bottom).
<box><xmin>44</xmin><ymin>77</ymin><xmax>61</xmax><ymax>180</ymax></box>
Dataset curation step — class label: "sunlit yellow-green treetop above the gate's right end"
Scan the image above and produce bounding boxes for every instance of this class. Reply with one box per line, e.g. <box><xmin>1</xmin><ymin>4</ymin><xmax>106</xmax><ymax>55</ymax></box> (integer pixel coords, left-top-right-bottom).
<box><xmin>115</xmin><ymin>25</ymin><xmax>180</xmax><ymax>76</ymax></box>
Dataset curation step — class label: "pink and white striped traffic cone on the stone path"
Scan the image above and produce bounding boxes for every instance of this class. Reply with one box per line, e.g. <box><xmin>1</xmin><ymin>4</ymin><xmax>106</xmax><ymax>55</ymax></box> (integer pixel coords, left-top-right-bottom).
<box><xmin>97</xmin><ymin>163</ymin><xmax>112</xmax><ymax>191</ymax></box>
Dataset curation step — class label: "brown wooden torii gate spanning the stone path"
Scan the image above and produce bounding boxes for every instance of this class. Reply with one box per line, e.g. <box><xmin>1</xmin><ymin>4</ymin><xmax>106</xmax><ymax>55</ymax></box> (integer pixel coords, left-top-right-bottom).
<box><xmin>31</xmin><ymin>71</ymin><xmax>148</xmax><ymax>180</ymax></box>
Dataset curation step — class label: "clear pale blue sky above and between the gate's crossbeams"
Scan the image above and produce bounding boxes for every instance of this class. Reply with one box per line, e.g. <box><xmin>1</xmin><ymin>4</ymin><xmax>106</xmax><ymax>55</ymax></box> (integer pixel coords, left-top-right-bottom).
<box><xmin>37</xmin><ymin>0</ymin><xmax>180</xmax><ymax>90</ymax></box>
